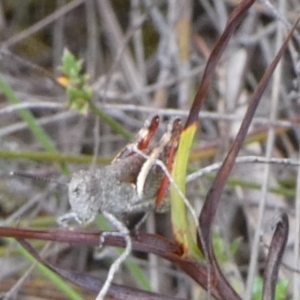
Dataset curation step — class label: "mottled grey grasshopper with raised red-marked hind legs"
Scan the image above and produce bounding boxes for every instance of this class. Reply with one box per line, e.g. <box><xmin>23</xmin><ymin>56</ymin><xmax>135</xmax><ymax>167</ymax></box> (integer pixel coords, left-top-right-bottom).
<box><xmin>59</xmin><ymin>117</ymin><xmax>181</xmax><ymax>223</ymax></box>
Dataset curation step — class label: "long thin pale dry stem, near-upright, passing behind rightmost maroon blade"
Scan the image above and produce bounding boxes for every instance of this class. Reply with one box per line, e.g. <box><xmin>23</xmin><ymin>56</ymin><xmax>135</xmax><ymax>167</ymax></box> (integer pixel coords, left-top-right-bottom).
<box><xmin>244</xmin><ymin>4</ymin><xmax>283</xmax><ymax>300</ymax></box>
